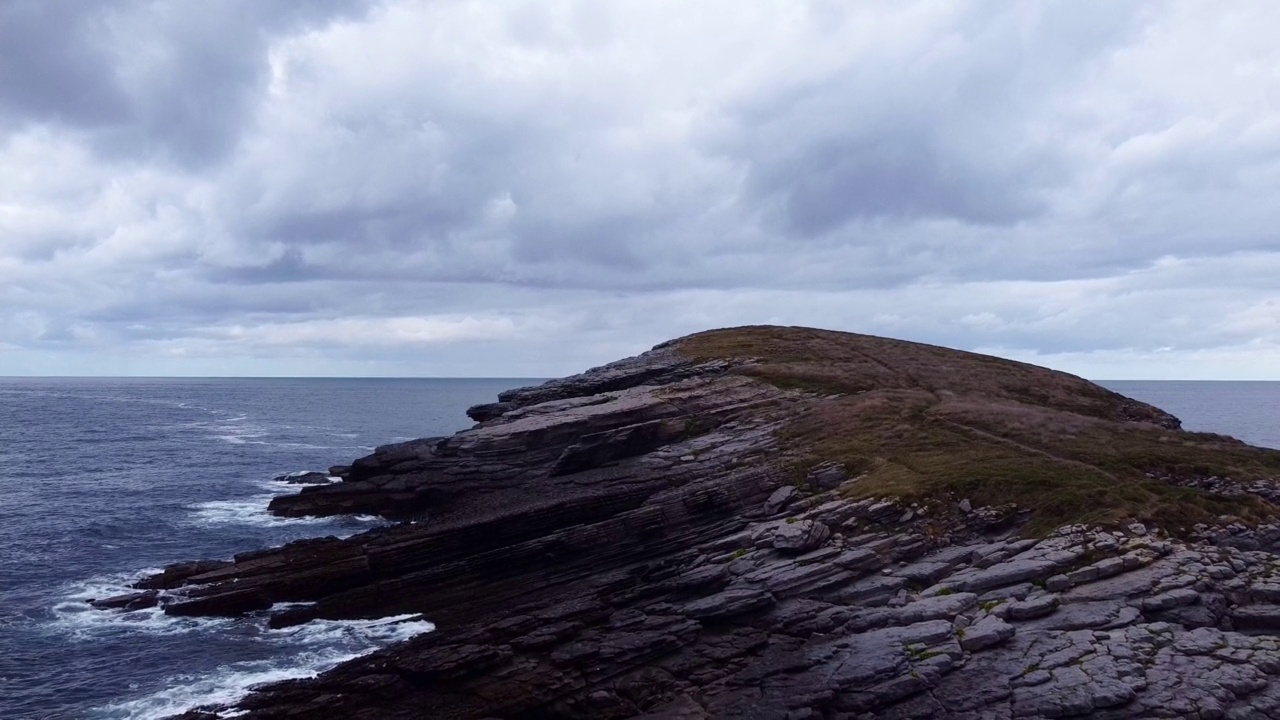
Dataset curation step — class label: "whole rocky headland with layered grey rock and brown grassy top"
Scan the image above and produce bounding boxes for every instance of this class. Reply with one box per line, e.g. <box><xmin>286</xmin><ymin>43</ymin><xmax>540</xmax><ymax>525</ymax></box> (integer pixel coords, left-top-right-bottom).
<box><xmin>99</xmin><ymin>327</ymin><xmax>1280</xmax><ymax>720</ymax></box>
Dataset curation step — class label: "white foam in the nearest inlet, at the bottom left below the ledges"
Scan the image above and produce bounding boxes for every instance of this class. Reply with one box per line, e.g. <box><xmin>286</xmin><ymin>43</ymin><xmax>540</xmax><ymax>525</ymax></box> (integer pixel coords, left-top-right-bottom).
<box><xmin>95</xmin><ymin>615</ymin><xmax>435</xmax><ymax>720</ymax></box>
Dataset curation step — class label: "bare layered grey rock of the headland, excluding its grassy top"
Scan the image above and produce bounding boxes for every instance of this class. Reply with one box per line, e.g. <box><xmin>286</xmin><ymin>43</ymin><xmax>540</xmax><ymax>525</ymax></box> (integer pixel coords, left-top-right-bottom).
<box><xmin>101</xmin><ymin>327</ymin><xmax>1280</xmax><ymax>720</ymax></box>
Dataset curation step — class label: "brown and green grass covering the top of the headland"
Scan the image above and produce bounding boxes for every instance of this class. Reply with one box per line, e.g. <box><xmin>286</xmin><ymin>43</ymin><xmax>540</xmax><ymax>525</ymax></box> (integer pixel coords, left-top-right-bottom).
<box><xmin>677</xmin><ymin>327</ymin><xmax>1280</xmax><ymax>533</ymax></box>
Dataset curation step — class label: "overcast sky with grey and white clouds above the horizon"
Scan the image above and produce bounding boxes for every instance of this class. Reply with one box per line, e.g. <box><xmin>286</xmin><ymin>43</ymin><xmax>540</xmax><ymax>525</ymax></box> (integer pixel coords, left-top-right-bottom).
<box><xmin>0</xmin><ymin>0</ymin><xmax>1280</xmax><ymax>379</ymax></box>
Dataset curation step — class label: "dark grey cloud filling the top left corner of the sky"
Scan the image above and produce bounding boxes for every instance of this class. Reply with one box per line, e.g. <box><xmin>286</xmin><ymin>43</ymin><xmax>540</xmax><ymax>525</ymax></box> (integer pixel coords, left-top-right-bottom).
<box><xmin>0</xmin><ymin>0</ymin><xmax>365</xmax><ymax>167</ymax></box>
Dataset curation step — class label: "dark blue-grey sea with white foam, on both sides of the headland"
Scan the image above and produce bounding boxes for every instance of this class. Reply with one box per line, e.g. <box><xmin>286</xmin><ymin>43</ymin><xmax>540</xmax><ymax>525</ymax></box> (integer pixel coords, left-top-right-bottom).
<box><xmin>0</xmin><ymin>378</ymin><xmax>1280</xmax><ymax>720</ymax></box>
